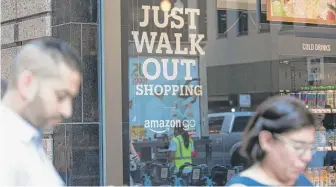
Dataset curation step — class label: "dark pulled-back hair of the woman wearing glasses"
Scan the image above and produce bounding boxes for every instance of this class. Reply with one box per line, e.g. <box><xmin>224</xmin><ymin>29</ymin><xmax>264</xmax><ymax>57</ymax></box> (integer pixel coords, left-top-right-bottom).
<box><xmin>240</xmin><ymin>96</ymin><xmax>316</xmax><ymax>163</ymax></box>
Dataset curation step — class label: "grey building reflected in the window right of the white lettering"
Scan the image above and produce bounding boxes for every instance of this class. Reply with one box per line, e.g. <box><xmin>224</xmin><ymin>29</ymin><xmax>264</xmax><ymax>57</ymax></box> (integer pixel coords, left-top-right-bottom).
<box><xmin>204</xmin><ymin>0</ymin><xmax>336</xmax><ymax>112</ymax></box>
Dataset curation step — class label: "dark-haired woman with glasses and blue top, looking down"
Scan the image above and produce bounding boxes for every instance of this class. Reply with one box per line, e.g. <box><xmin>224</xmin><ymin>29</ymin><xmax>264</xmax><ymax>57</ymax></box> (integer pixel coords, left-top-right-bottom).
<box><xmin>227</xmin><ymin>96</ymin><xmax>316</xmax><ymax>186</ymax></box>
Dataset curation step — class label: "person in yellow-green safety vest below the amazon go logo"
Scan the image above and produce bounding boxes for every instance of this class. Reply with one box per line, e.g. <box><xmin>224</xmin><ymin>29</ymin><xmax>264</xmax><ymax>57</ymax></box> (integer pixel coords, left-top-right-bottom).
<box><xmin>168</xmin><ymin>125</ymin><xmax>195</xmax><ymax>173</ymax></box>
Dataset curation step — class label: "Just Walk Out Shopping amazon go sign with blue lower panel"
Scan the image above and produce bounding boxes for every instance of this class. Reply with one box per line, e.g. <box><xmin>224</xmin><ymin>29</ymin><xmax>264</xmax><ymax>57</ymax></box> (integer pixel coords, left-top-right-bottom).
<box><xmin>129</xmin><ymin>5</ymin><xmax>205</xmax><ymax>138</ymax></box>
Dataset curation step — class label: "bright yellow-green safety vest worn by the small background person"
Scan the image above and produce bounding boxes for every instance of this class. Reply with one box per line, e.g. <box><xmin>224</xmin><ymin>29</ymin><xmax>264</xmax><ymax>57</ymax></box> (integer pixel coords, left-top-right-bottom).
<box><xmin>173</xmin><ymin>135</ymin><xmax>193</xmax><ymax>169</ymax></box>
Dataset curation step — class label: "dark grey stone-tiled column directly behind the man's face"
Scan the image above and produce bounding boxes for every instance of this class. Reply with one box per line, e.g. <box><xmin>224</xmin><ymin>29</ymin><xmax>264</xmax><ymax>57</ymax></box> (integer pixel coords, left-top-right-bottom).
<box><xmin>52</xmin><ymin>0</ymin><xmax>100</xmax><ymax>186</ymax></box>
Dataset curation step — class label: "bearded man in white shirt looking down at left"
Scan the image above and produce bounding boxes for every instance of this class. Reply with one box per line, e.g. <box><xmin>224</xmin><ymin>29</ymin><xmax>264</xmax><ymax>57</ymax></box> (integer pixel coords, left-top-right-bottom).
<box><xmin>0</xmin><ymin>38</ymin><xmax>81</xmax><ymax>186</ymax></box>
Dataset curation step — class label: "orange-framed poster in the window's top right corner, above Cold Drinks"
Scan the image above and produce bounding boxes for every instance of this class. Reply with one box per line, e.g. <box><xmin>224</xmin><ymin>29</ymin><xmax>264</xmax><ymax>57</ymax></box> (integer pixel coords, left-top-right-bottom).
<box><xmin>267</xmin><ymin>0</ymin><xmax>336</xmax><ymax>25</ymax></box>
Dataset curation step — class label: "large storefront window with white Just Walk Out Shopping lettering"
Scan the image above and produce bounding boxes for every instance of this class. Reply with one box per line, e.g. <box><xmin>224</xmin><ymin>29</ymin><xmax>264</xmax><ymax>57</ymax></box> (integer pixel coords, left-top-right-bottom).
<box><xmin>123</xmin><ymin>0</ymin><xmax>336</xmax><ymax>185</ymax></box>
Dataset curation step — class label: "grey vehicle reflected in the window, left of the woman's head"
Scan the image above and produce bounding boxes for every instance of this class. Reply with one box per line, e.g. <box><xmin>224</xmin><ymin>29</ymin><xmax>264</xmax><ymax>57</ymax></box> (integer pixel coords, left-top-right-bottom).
<box><xmin>208</xmin><ymin>112</ymin><xmax>253</xmax><ymax>167</ymax></box>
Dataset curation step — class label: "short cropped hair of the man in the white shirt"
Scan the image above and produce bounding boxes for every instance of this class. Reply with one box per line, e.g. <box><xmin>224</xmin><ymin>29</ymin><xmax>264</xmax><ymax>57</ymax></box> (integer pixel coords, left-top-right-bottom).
<box><xmin>8</xmin><ymin>37</ymin><xmax>82</xmax><ymax>87</ymax></box>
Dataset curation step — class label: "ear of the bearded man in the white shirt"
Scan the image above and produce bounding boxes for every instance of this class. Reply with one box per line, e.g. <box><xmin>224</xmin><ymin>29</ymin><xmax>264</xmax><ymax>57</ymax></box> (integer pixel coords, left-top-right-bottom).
<box><xmin>17</xmin><ymin>70</ymin><xmax>38</xmax><ymax>102</ymax></box>
